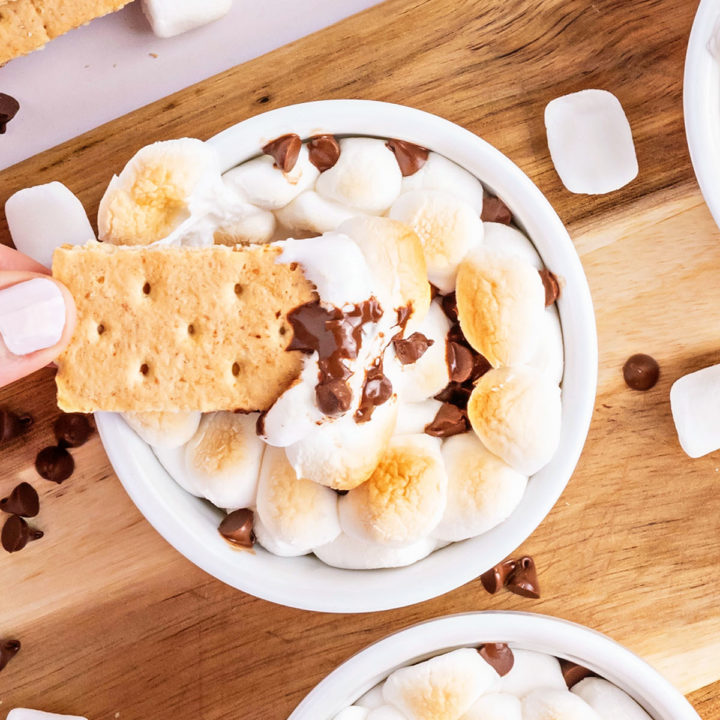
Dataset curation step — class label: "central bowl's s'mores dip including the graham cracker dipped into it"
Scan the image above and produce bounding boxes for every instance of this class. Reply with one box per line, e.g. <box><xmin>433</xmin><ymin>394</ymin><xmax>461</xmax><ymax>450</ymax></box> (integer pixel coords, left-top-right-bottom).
<box><xmin>53</xmin><ymin>134</ymin><xmax>563</xmax><ymax>569</ymax></box>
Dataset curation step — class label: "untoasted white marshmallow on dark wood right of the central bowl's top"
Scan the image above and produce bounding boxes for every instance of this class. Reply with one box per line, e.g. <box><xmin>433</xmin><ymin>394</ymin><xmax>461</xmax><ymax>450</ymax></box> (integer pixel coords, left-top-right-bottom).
<box><xmin>545</xmin><ymin>90</ymin><xmax>638</xmax><ymax>195</ymax></box>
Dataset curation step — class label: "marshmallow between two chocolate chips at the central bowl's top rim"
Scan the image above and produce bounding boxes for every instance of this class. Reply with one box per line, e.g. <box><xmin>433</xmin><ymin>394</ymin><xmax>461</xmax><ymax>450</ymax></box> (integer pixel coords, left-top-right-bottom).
<box><xmin>315</xmin><ymin>137</ymin><xmax>402</xmax><ymax>214</ymax></box>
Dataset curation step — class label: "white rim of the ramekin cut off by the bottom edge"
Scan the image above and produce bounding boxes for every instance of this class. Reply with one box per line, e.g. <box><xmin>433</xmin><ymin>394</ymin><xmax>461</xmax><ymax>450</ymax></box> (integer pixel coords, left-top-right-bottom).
<box><xmin>288</xmin><ymin>612</ymin><xmax>700</xmax><ymax>720</ymax></box>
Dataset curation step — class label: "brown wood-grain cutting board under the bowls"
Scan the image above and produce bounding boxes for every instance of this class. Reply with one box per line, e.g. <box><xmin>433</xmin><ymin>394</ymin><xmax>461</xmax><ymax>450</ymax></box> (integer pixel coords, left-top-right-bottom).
<box><xmin>0</xmin><ymin>0</ymin><xmax>720</xmax><ymax>720</ymax></box>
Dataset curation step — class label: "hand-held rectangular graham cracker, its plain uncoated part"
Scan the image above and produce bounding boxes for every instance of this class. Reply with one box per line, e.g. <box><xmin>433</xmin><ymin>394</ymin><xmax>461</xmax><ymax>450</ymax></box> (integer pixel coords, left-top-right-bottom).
<box><xmin>53</xmin><ymin>242</ymin><xmax>316</xmax><ymax>412</ymax></box>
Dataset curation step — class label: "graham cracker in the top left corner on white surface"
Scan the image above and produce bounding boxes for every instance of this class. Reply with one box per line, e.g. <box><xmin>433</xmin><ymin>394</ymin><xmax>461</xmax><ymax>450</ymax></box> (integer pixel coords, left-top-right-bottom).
<box><xmin>0</xmin><ymin>0</ymin><xmax>130</xmax><ymax>65</ymax></box>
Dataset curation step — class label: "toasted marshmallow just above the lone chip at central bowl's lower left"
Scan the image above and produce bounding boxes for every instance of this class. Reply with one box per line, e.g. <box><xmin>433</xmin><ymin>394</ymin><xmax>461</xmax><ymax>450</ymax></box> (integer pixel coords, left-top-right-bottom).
<box><xmin>185</xmin><ymin>412</ymin><xmax>265</xmax><ymax>510</ymax></box>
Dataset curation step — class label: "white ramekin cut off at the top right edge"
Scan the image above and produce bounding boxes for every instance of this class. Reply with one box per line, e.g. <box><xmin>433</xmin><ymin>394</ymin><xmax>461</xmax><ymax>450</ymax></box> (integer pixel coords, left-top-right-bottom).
<box><xmin>683</xmin><ymin>0</ymin><xmax>720</xmax><ymax>226</ymax></box>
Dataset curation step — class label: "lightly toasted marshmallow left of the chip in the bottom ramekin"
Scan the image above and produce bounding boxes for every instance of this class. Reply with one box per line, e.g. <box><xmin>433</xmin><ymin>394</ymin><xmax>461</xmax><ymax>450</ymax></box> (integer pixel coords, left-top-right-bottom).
<box><xmin>383</xmin><ymin>648</ymin><xmax>498</xmax><ymax>720</ymax></box>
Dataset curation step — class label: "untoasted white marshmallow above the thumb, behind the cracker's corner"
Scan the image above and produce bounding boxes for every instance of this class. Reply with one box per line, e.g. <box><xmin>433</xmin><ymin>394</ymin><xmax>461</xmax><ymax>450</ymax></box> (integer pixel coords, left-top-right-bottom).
<box><xmin>5</xmin><ymin>182</ymin><xmax>95</xmax><ymax>269</ymax></box>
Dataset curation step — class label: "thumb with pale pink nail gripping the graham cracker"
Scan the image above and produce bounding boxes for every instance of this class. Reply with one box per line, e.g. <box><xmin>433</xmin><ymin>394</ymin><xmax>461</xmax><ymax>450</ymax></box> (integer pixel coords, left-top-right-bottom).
<box><xmin>0</xmin><ymin>270</ymin><xmax>75</xmax><ymax>387</ymax></box>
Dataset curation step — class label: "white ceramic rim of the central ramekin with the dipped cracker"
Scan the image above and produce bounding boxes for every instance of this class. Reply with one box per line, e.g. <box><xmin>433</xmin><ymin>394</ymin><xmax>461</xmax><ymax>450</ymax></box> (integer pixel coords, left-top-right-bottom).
<box><xmin>97</xmin><ymin>100</ymin><xmax>597</xmax><ymax>612</ymax></box>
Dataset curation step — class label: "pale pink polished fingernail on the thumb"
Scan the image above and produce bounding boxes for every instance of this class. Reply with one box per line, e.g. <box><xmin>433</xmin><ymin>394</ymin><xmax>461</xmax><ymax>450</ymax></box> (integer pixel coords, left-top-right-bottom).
<box><xmin>0</xmin><ymin>278</ymin><xmax>65</xmax><ymax>355</ymax></box>
